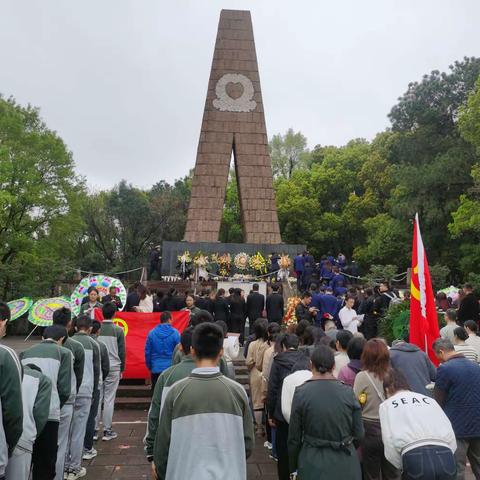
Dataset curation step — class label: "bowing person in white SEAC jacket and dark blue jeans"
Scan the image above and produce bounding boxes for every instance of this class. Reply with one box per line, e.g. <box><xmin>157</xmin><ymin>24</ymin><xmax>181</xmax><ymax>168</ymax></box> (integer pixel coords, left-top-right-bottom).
<box><xmin>379</xmin><ymin>369</ymin><xmax>457</xmax><ymax>480</ymax></box>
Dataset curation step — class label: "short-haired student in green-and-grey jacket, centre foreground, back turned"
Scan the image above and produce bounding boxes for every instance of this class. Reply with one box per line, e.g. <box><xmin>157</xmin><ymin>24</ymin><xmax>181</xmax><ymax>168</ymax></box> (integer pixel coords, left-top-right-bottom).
<box><xmin>153</xmin><ymin>323</ymin><xmax>254</xmax><ymax>480</ymax></box>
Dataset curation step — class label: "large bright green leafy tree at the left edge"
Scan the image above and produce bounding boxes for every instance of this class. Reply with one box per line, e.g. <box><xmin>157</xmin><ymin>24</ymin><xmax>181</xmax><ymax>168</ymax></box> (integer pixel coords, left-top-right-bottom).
<box><xmin>0</xmin><ymin>97</ymin><xmax>84</xmax><ymax>298</ymax></box>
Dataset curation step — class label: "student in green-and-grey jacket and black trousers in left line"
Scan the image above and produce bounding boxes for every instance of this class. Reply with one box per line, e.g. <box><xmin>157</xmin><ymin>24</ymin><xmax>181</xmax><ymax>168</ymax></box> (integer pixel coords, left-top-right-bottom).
<box><xmin>20</xmin><ymin>325</ymin><xmax>74</xmax><ymax>480</ymax></box>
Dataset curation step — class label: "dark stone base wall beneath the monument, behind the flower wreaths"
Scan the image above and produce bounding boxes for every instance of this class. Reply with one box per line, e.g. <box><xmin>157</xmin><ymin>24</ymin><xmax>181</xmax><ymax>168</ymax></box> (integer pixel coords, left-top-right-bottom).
<box><xmin>162</xmin><ymin>242</ymin><xmax>306</xmax><ymax>275</ymax></box>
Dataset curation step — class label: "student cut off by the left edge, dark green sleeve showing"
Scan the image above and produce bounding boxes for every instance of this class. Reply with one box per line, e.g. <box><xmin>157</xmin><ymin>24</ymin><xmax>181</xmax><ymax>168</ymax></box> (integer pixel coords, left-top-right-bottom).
<box><xmin>0</xmin><ymin>302</ymin><xmax>23</xmax><ymax>479</ymax></box>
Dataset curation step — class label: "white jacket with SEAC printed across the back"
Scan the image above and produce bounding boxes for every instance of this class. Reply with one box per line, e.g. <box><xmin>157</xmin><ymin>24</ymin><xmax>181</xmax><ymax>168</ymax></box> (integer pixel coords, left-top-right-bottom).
<box><xmin>379</xmin><ymin>390</ymin><xmax>457</xmax><ymax>468</ymax></box>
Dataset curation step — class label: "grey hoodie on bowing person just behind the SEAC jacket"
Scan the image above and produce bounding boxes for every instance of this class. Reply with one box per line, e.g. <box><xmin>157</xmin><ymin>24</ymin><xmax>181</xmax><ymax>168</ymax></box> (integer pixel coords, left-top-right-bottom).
<box><xmin>390</xmin><ymin>342</ymin><xmax>437</xmax><ymax>396</ymax></box>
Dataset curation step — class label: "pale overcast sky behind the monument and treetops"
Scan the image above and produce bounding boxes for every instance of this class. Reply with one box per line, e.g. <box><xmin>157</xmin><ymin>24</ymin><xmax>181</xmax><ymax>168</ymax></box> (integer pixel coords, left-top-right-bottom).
<box><xmin>0</xmin><ymin>0</ymin><xmax>480</xmax><ymax>188</ymax></box>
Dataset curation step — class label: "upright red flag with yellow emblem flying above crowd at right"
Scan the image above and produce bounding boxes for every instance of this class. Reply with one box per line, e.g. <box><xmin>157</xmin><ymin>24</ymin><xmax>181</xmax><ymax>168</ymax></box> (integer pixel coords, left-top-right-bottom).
<box><xmin>410</xmin><ymin>213</ymin><xmax>440</xmax><ymax>365</ymax></box>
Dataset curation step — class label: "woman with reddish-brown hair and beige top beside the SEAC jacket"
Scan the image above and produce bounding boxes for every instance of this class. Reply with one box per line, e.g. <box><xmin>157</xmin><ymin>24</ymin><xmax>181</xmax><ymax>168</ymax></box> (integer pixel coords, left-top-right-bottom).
<box><xmin>353</xmin><ymin>338</ymin><xmax>400</xmax><ymax>480</ymax></box>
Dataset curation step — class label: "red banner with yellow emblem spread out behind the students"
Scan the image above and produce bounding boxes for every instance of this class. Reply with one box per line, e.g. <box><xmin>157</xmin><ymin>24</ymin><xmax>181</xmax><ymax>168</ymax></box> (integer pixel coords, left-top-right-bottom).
<box><xmin>95</xmin><ymin>310</ymin><xmax>190</xmax><ymax>378</ymax></box>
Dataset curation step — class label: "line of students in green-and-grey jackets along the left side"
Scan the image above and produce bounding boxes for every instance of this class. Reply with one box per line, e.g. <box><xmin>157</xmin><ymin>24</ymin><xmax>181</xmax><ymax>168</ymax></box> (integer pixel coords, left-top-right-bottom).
<box><xmin>0</xmin><ymin>302</ymin><xmax>125</xmax><ymax>480</ymax></box>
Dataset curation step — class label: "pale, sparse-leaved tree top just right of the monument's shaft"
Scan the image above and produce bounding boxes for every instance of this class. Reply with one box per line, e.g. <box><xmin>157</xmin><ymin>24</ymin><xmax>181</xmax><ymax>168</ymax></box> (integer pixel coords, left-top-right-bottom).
<box><xmin>269</xmin><ymin>128</ymin><xmax>308</xmax><ymax>178</ymax></box>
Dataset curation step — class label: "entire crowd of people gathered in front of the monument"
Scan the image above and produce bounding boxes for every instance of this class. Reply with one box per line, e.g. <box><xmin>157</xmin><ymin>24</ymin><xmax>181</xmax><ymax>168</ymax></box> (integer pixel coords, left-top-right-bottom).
<box><xmin>0</xmin><ymin>282</ymin><xmax>480</xmax><ymax>480</ymax></box>
